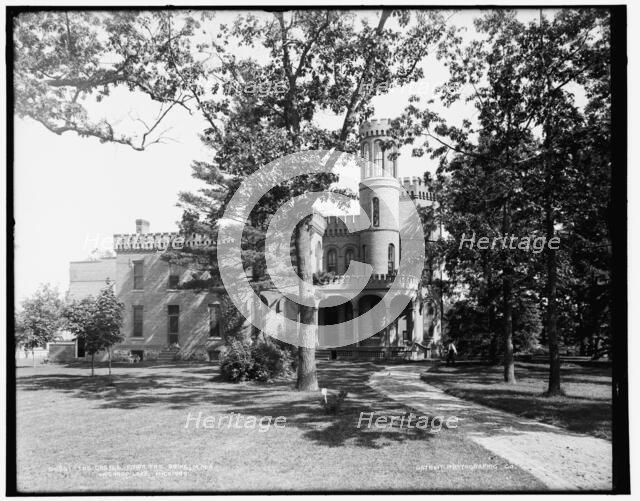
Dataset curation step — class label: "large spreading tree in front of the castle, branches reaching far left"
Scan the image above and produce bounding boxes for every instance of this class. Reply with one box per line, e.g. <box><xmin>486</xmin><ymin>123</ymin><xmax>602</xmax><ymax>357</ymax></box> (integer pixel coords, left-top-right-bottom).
<box><xmin>15</xmin><ymin>10</ymin><xmax>456</xmax><ymax>390</ymax></box>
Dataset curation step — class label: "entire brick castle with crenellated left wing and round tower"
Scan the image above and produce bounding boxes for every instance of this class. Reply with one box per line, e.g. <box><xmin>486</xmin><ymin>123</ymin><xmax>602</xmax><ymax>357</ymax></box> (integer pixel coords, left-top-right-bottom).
<box><xmin>51</xmin><ymin>119</ymin><xmax>440</xmax><ymax>361</ymax></box>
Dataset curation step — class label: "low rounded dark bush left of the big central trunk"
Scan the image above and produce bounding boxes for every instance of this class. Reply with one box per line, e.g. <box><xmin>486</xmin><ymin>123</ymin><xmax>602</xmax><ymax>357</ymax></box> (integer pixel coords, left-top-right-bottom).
<box><xmin>220</xmin><ymin>339</ymin><xmax>292</xmax><ymax>383</ymax></box>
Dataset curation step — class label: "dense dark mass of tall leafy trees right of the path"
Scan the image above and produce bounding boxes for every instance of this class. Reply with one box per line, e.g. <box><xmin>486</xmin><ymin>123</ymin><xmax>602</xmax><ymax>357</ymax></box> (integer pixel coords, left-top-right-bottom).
<box><xmin>398</xmin><ymin>9</ymin><xmax>611</xmax><ymax>392</ymax></box>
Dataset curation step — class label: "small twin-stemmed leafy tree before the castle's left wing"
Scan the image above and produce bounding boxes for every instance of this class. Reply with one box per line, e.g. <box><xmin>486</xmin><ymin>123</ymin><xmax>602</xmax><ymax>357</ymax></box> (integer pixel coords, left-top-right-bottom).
<box><xmin>64</xmin><ymin>281</ymin><xmax>124</xmax><ymax>380</ymax></box>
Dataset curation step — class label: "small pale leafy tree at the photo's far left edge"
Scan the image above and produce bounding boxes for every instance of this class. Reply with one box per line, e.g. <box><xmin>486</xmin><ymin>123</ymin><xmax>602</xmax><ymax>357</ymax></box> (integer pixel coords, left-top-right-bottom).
<box><xmin>15</xmin><ymin>284</ymin><xmax>63</xmax><ymax>367</ymax></box>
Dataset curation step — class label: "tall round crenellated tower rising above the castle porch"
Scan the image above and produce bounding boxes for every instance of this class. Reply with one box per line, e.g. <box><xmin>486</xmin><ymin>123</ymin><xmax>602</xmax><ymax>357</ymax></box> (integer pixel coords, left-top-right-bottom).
<box><xmin>359</xmin><ymin>119</ymin><xmax>401</xmax><ymax>275</ymax></box>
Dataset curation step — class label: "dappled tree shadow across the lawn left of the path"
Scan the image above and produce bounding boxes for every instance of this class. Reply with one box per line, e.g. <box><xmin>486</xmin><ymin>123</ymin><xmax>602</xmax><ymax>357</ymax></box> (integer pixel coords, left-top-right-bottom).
<box><xmin>17</xmin><ymin>361</ymin><xmax>440</xmax><ymax>449</ymax></box>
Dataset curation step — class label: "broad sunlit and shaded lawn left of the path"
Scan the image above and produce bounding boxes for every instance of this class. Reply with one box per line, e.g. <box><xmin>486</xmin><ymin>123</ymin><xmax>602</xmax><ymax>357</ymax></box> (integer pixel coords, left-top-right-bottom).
<box><xmin>17</xmin><ymin>362</ymin><xmax>544</xmax><ymax>493</ymax></box>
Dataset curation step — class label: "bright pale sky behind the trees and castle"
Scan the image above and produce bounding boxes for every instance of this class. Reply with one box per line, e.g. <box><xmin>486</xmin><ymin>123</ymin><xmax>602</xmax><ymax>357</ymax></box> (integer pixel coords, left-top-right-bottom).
<box><xmin>14</xmin><ymin>10</ymin><xmax>560</xmax><ymax>302</ymax></box>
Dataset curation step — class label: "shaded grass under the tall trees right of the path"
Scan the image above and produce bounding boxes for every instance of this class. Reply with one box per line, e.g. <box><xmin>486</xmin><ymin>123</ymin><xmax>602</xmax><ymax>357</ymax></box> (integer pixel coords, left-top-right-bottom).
<box><xmin>422</xmin><ymin>362</ymin><xmax>611</xmax><ymax>440</ymax></box>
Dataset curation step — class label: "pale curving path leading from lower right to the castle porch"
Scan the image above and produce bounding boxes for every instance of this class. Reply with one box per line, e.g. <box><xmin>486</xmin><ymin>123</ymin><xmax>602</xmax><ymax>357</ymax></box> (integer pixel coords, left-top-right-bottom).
<box><xmin>369</xmin><ymin>365</ymin><xmax>612</xmax><ymax>491</ymax></box>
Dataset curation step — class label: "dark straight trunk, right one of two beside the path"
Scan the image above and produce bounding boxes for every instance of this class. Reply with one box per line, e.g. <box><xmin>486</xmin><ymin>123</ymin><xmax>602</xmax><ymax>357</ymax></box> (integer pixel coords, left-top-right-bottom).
<box><xmin>545</xmin><ymin>207</ymin><xmax>564</xmax><ymax>396</ymax></box>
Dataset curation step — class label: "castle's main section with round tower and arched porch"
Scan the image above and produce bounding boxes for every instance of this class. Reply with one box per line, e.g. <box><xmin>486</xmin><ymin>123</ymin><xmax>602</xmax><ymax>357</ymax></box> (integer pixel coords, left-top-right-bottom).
<box><xmin>262</xmin><ymin>119</ymin><xmax>441</xmax><ymax>359</ymax></box>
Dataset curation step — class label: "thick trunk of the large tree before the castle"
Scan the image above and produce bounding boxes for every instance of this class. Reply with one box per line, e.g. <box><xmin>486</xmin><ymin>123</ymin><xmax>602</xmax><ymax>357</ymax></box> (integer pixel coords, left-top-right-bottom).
<box><xmin>295</xmin><ymin>217</ymin><xmax>318</xmax><ymax>391</ymax></box>
